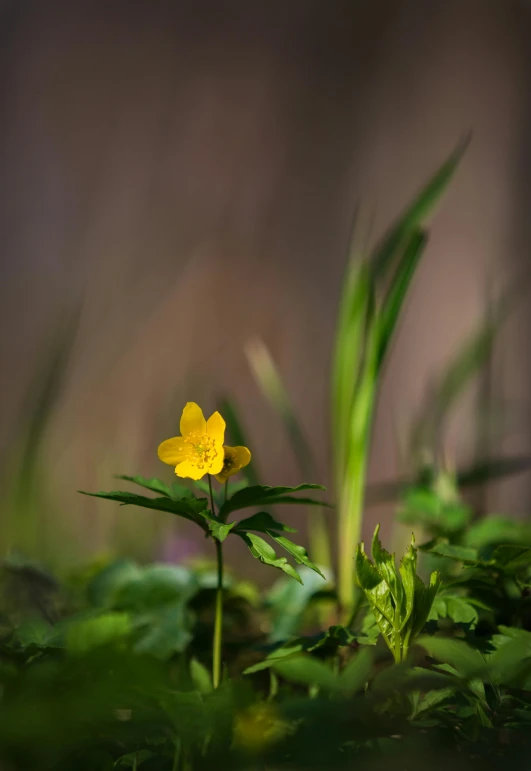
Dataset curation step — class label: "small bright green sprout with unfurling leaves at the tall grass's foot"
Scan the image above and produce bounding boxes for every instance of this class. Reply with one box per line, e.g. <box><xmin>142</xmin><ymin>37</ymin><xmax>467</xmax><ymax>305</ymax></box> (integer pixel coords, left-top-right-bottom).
<box><xmin>356</xmin><ymin>525</ymin><xmax>441</xmax><ymax>663</ymax></box>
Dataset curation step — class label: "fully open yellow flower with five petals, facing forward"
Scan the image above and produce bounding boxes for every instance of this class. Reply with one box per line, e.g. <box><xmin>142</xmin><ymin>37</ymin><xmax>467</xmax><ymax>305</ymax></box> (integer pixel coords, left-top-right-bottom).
<box><xmin>158</xmin><ymin>402</ymin><xmax>225</xmax><ymax>479</ymax></box>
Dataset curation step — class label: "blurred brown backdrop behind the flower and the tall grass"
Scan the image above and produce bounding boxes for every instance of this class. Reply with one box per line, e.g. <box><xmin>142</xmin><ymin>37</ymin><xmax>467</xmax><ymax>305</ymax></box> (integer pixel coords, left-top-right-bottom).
<box><xmin>0</xmin><ymin>0</ymin><xmax>531</xmax><ymax>571</ymax></box>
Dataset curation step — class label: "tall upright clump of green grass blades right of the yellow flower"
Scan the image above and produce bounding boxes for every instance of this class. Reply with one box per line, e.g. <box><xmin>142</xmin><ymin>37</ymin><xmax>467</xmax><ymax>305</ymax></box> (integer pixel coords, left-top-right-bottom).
<box><xmin>331</xmin><ymin>145</ymin><xmax>465</xmax><ymax>619</ymax></box>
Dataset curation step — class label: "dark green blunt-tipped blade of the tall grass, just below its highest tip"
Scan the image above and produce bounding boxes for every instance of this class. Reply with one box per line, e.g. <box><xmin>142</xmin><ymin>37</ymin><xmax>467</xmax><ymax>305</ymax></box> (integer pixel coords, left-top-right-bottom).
<box><xmin>378</xmin><ymin>228</ymin><xmax>428</xmax><ymax>366</ymax></box>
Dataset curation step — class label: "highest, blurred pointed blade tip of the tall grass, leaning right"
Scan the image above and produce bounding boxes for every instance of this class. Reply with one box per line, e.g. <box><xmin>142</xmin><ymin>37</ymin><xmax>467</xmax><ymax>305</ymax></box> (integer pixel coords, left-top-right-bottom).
<box><xmin>372</xmin><ymin>141</ymin><xmax>468</xmax><ymax>278</ymax></box>
